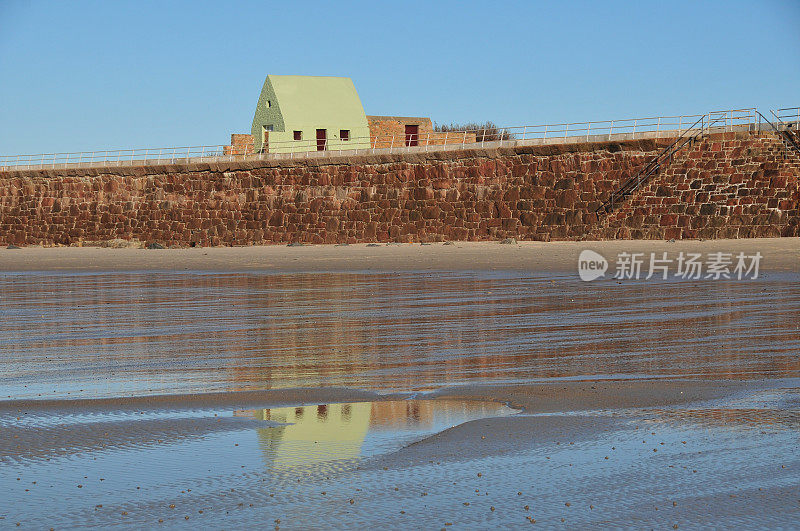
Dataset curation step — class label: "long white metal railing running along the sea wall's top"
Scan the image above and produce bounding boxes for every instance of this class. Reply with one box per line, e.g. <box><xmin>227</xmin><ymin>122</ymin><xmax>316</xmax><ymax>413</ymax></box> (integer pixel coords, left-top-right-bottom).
<box><xmin>0</xmin><ymin>109</ymin><xmax>764</xmax><ymax>170</ymax></box>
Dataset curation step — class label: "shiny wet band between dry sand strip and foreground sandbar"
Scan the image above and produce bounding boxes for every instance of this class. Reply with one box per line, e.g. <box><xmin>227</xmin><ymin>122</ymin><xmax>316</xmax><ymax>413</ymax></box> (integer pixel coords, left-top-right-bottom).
<box><xmin>0</xmin><ymin>271</ymin><xmax>800</xmax><ymax>400</ymax></box>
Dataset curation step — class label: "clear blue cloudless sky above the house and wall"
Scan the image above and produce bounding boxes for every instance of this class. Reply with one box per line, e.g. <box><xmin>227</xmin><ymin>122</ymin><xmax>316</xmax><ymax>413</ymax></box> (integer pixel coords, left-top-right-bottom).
<box><xmin>0</xmin><ymin>0</ymin><xmax>800</xmax><ymax>155</ymax></box>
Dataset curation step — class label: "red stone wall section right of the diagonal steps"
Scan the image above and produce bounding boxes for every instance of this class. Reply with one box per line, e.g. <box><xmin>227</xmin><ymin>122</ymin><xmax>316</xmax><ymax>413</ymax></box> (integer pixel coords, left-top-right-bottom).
<box><xmin>591</xmin><ymin>133</ymin><xmax>800</xmax><ymax>239</ymax></box>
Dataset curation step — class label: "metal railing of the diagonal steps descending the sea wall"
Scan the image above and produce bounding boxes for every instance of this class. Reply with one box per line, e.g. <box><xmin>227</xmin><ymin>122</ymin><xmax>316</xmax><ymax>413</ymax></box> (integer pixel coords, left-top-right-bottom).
<box><xmin>595</xmin><ymin>108</ymin><xmax>774</xmax><ymax>215</ymax></box>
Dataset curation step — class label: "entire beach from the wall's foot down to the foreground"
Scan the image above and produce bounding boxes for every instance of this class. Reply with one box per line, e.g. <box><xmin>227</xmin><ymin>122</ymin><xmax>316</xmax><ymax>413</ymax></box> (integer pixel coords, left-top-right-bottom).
<box><xmin>0</xmin><ymin>239</ymin><xmax>800</xmax><ymax>529</ymax></box>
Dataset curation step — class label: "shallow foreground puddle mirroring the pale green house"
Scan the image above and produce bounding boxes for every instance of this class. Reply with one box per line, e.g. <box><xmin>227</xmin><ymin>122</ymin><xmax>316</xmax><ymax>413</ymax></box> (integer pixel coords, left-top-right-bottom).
<box><xmin>0</xmin><ymin>400</ymin><xmax>517</xmax><ymax>528</ymax></box>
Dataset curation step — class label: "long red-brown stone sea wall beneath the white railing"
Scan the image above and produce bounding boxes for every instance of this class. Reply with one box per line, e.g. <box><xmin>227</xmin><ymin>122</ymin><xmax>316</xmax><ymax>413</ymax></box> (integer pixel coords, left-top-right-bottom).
<box><xmin>0</xmin><ymin>133</ymin><xmax>800</xmax><ymax>246</ymax></box>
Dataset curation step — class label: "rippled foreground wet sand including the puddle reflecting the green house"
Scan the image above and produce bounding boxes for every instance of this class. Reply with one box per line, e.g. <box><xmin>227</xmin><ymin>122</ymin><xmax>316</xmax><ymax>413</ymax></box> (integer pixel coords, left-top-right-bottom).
<box><xmin>0</xmin><ymin>379</ymin><xmax>800</xmax><ymax>529</ymax></box>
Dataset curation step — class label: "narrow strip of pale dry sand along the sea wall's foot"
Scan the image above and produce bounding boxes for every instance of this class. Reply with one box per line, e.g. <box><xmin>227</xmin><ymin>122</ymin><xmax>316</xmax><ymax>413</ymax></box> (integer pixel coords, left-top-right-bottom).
<box><xmin>0</xmin><ymin>238</ymin><xmax>800</xmax><ymax>272</ymax></box>
